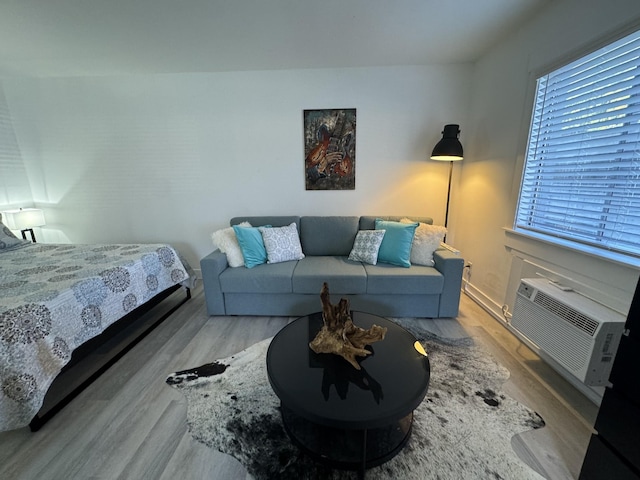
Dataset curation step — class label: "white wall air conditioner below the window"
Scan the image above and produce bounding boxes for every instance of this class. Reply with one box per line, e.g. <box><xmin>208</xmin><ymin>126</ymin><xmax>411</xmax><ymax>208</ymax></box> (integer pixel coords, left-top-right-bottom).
<box><xmin>511</xmin><ymin>278</ymin><xmax>625</xmax><ymax>385</ymax></box>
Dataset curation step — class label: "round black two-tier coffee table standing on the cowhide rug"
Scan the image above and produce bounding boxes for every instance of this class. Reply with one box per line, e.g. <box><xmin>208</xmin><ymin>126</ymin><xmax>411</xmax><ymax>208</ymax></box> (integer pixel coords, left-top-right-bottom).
<box><xmin>267</xmin><ymin>312</ymin><xmax>430</xmax><ymax>474</ymax></box>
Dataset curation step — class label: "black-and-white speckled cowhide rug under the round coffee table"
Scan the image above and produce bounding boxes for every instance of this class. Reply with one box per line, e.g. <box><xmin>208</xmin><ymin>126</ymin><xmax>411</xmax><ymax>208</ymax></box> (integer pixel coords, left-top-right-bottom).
<box><xmin>167</xmin><ymin>319</ymin><xmax>544</xmax><ymax>480</ymax></box>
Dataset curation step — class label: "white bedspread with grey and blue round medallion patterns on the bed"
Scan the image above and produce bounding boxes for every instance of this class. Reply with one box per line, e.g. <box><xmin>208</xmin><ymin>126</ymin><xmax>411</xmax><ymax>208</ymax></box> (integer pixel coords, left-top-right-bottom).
<box><xmin>0</xmin><ymin>243</ymin><xmax>195</xmax><ymax>431</ymax></box>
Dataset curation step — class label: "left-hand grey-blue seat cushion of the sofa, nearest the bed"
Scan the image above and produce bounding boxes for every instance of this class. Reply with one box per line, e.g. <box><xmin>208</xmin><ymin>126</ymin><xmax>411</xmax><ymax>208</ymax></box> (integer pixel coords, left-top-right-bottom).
<box><xmin>219</xmin><ymin>262</ymin><xmax>296</xmax><ymax>293</ymax></box>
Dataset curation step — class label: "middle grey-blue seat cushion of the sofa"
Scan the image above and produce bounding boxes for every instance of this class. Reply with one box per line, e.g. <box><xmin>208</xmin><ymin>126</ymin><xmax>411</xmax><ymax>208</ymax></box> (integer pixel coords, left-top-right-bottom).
<box><xmin>293</xmin><ymin>256</ymin><xmax>367</xmax><ymax>294</ymax></box>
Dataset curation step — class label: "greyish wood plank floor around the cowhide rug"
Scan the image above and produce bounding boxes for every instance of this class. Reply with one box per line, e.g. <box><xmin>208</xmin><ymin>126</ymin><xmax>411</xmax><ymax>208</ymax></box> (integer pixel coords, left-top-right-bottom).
<box><xmin>0</xmin><ymin>287</ymin><xmax>597</xmax><ymax>480</ymax></box>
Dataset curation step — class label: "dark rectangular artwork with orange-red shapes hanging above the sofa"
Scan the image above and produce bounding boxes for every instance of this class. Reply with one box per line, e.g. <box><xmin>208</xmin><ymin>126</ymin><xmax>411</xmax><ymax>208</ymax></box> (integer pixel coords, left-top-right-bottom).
<box><xmin>304</xmin><ymin>108</ymin><xmax>356</xmax><ymax>190</ymax></box>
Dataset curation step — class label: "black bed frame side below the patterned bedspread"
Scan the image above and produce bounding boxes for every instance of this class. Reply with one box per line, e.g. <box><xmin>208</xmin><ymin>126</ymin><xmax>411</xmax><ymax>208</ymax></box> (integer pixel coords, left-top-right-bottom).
<box><xmin>29</xmin><ymin>285</ymin><xmax>191</xmax><ymax>432</ymax></box>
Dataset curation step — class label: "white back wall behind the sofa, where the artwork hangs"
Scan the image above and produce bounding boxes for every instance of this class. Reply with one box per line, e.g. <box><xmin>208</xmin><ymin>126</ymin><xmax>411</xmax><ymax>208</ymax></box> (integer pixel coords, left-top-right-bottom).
<box><xmin>0</xmin><ymin>65</ymin><xmax>473</xmax><ymax>268</ymax></box>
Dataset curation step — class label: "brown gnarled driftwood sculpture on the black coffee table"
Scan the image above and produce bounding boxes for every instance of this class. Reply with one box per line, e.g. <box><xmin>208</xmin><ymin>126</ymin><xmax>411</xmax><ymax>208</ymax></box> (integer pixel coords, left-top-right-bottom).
<box><xmin>309</xmin><ymin>282</ymin><xmax>387</xmax><ymax>370</ymax></box>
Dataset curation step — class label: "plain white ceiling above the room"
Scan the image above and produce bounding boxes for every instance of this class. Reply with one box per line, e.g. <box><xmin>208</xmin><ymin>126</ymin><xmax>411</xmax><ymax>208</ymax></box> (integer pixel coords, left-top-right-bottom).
<box><xmin>0</xmin><ymin>0</ymin><xmax>551</xmax><ymax>77</ymax></box>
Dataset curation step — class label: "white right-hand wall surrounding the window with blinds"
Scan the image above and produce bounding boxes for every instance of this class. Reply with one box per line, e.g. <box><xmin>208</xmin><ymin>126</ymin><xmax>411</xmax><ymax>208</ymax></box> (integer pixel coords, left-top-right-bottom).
<box><xmin>450</xmin><ymin>0</ymin><xmax>640</xmax><ymax>314</ymax></box>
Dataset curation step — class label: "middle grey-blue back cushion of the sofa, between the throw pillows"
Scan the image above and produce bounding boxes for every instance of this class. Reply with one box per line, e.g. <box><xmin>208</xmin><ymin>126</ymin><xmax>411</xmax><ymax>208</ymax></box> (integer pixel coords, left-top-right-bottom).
<box><xmin>300</xmin><ymin>216</ymin><xmax>359</xmax><ymax>257</ymax></box>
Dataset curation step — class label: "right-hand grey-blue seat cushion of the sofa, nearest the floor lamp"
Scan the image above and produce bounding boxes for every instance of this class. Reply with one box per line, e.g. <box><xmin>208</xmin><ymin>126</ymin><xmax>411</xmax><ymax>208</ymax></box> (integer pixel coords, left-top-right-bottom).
<box><xmin>364</xmin><ymin>263</ymin><xmax>444</xmax><ymax>295</ymax></box>
